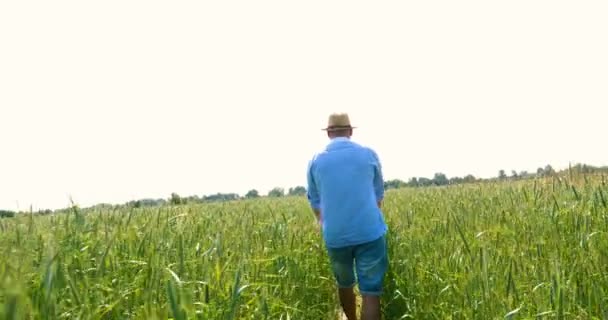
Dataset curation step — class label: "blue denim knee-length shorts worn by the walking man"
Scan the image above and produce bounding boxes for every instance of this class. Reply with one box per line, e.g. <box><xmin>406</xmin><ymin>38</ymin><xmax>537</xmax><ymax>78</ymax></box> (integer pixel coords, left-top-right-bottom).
<box><xmin>327</xmin><ymin>235</ymin><xmax>388</xmax><ymax>296</ymax></box>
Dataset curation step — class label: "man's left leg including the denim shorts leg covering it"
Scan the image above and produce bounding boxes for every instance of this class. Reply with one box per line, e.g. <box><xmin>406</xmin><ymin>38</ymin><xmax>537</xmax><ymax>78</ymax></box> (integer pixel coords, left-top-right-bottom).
<box><xmin>327</xmin><ymin>247</ymin><xmax>357</xmax><ymax>320</ymax></box>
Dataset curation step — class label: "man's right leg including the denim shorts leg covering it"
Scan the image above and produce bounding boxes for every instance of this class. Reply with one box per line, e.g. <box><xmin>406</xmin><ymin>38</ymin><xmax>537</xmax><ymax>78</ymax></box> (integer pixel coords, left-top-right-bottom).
<box><xmin>355</xmin><ymin>236</ymin><xmax>388</xmax><ymax>320</ymax></box>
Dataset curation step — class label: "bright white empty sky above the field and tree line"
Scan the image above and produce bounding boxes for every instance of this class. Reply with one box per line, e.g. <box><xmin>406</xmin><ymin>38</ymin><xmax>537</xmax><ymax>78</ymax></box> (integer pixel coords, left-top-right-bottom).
<box><xmin>0</xmin><ymin>0</ymin><xmax>608</xmax><ymax>209</ymax></box>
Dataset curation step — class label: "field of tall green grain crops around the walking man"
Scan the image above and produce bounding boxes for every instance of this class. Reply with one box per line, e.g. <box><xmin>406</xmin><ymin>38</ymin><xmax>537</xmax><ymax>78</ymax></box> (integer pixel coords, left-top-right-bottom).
<box><xmin>0</xmin><ymin>178</ymin><xmax>608</xmax><ymax>320</ymax></box>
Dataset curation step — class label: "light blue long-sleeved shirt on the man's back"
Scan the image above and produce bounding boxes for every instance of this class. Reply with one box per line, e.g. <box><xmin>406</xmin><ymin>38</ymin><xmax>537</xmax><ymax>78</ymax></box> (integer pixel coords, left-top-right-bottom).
<box><xmin>307</xmin><ymin>138</ymin><xmax>387</xmax><ymax>248</ymax></box>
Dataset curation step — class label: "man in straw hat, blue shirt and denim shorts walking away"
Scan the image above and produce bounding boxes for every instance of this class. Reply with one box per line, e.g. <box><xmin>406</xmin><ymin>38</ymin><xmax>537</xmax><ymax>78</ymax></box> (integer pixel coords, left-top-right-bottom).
<box><xmin>307</xmin><ymin>113</ymin><xmax>388</xmax><ymax>320</ymax></box>
